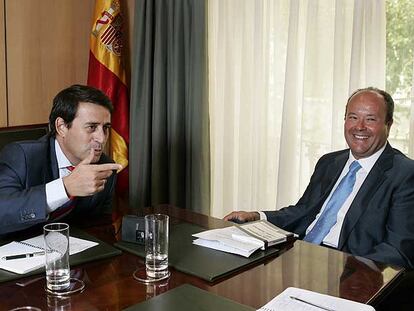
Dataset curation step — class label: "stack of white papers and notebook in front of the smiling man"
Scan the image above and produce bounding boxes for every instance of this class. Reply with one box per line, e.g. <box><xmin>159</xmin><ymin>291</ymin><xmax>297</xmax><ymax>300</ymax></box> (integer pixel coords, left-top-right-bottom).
<box><xmin>193</xmin><ymin>220</ymin><xmax>294</xmax><ymax>257</ymax></box>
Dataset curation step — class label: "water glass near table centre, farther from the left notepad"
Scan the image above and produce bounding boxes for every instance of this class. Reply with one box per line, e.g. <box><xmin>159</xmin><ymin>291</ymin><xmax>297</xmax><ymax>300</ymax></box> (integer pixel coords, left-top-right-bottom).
<box><xmin>145</xmin><ymin>214</ymin><xmax>169</xmax><ymax>279</ymax></box>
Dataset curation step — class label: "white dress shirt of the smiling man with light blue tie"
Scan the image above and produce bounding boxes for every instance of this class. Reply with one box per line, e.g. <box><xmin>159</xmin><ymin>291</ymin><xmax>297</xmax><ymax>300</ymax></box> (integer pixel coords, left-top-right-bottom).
<box><xmin>259</xmin><ymin>144</ymin><xmax>386</xmax><ymax>248</ymax></box>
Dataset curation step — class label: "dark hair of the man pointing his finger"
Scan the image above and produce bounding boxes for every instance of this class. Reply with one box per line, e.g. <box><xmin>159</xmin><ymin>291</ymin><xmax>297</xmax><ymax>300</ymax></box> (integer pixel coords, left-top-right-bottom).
<box><xmin>49</xmin><ymin>84</ymin><xmax>114</xmax><ymax>136</ymax></box>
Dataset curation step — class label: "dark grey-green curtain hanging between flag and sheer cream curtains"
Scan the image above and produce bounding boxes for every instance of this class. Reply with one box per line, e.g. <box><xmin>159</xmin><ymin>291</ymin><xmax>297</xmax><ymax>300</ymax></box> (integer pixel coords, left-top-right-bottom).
<box><xmin>129</xmin><ymin>0</ymin><xmax>210</xmax><ymax>214</ymax></box>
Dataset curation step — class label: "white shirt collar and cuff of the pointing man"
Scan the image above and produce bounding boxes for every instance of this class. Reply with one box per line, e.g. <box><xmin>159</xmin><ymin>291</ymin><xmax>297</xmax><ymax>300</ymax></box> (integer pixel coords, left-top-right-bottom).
<box><xmin>46</xmin><ymin>139</ymin><xmax>72</xmax><ymax>213</ymax></box>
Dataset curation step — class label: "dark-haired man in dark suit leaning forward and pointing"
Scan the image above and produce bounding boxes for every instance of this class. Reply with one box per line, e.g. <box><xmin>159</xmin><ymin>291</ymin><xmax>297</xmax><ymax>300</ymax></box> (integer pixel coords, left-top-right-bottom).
<box><xmin>0</xmin><ymin>85</ymin><xmax>121</xmax><ymax>234</ymax></box>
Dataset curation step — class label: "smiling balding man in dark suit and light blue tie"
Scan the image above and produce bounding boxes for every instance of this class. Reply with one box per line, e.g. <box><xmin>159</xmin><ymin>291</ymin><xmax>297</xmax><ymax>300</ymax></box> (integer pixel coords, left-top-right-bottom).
<box><xmin>224</xmin><ymin>88</ymin><xmax>414</xmax><ymax>268</ymax></box>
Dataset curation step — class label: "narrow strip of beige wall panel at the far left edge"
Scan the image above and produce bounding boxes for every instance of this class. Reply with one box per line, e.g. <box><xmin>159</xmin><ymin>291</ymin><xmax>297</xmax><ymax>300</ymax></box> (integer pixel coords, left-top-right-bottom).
<box><xmin>0</xmin><ymin>0</ymin><xmax>7</xmax><ymax>127</ymax></box>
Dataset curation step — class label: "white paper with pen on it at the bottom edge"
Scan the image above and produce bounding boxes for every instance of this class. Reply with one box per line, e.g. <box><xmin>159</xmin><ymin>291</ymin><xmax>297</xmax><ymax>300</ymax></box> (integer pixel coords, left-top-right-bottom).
<box><xmin>258</xmin><ymin>287</ymin><xmax>375</xmax><ymax>311</ymax></box>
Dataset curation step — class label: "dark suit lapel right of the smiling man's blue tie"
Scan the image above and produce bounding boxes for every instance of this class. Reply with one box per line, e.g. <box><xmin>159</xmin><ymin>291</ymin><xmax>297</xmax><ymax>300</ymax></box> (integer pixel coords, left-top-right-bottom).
<box><xmin>338</xmin><ymin>144</ymin><xmax>394</xmax><ymax>249</ymax></box>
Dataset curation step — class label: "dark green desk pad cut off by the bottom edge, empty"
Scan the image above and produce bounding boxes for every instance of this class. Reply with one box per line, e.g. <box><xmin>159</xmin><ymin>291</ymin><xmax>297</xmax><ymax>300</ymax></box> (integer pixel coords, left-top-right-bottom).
<box><xmin>124</xmin><ymin>284</ymin><xmax>255</xmax><ymax>311</ymax></box>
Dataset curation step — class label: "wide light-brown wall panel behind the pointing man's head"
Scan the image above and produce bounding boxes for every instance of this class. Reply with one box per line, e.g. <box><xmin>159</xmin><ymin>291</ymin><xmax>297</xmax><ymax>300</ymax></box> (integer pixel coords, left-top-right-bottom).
<box><xmin>5</xmin><ymin>0</ymin><xmax>95</xmax><ymax>126</ymax></box>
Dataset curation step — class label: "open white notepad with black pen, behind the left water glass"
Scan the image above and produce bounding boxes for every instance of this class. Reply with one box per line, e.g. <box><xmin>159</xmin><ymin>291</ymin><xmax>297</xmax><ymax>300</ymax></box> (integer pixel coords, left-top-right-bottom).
<box><xmin>0</xmin><ymin>235</ymin><xmax>98</xmax><ymax>274</ymax></box>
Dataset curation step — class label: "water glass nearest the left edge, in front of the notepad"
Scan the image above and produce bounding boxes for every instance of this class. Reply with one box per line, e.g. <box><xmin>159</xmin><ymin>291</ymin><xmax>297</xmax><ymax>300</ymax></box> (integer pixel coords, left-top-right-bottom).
<box><xmin>43</xmin><ymin>223</ymin><xmax>70</xmax><ymax>292</ymax></box>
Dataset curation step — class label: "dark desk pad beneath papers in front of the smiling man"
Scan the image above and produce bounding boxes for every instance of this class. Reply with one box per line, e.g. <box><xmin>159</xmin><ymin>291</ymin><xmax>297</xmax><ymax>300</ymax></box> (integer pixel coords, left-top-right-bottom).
<box><xmin>114</xmin><ymin>223</ymin><xmax>290</xmax><ymax>282</ymax></box>
